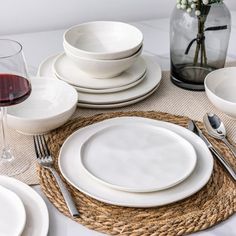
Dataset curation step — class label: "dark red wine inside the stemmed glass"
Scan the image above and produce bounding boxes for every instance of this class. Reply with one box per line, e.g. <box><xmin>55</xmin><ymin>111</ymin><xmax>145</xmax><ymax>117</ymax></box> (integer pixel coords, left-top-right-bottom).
<box><xmin>0</xmin><ymin>74</ymin><xmax>31</xmax><ymax>107</ymax></box>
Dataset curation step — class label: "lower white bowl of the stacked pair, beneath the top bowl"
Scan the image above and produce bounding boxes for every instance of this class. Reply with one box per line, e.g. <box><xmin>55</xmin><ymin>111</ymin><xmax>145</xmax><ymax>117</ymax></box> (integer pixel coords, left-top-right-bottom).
<box><xmin>65</xmin><ymin>47</ymin><xmax>142</xmax><ymax>79</ymax></box>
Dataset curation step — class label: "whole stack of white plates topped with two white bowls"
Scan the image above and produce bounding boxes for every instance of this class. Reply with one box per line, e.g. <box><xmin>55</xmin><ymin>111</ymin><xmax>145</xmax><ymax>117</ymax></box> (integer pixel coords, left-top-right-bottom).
<box><xmin>38</xmin><ymin>21</ymin><xmax>161</xmax><ymax>108</ymax></box>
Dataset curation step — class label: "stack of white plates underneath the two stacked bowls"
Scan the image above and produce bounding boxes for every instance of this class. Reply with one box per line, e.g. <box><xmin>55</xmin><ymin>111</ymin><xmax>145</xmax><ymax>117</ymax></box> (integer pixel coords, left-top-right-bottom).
<box><xmin>38</xmin><ymin>53</ymin><xmax>161</xmax><ymax>108</ymax></box>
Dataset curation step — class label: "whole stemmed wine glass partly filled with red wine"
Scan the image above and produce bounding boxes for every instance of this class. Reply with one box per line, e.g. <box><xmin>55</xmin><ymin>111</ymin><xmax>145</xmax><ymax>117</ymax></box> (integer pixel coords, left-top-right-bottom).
<box><xmin>0</xmin><ymin>39</ymin><xmax>31</xmax><ymax>176</ymax></box>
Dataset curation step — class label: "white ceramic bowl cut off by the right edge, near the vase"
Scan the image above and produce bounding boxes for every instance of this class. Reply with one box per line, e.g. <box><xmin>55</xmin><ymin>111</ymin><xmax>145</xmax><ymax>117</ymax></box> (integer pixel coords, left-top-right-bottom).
<box><xmin>205</xmin><ymin>67</ymin><xmax>236</xmax><ymax>118</ymax></box>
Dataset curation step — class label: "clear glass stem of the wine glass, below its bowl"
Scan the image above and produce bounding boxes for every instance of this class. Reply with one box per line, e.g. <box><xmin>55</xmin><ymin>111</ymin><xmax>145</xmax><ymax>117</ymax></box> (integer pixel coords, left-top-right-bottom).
<box><xmin>1</xmin><ymin>107</ymin><xmax>13</xmax><ymax>161</ymax></box>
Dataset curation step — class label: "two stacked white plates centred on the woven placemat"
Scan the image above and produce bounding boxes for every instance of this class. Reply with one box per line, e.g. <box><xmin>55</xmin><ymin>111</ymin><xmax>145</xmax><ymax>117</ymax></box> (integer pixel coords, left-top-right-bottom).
<box><xmin>59</xmin><ymin>117</ymin><xmax>213</xmax><ymax>207</ymax></box>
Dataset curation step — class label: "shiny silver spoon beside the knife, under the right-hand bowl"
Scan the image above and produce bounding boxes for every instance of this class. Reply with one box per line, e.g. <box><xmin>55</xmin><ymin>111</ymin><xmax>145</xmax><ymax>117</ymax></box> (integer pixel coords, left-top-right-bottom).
<box><xmin>203</xmin><ymin>113</ymin><xmax>236</xmax><ymax>157</ymax></box>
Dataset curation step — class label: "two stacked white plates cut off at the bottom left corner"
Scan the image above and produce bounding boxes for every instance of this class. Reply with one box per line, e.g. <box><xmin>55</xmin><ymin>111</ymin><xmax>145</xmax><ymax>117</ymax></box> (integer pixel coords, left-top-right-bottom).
<box><xmin>0</xmin><ymin>175</ymin><xmax>49</xmax><ymax>236</ymax></box>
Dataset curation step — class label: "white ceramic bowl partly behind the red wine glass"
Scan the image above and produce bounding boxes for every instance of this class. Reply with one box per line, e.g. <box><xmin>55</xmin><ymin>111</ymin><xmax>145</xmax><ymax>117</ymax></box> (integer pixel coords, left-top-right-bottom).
<box><xmin>7</xmin><ymin>77</ymin><xmax>78</xmax><ymax>135</ymax></box>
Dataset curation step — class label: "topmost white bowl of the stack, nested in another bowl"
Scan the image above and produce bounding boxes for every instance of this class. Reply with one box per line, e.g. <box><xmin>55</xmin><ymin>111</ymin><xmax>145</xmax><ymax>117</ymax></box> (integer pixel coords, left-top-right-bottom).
<box><xmin>63</xmin><ymin>21</ymin><xmax>143</xmax><ymax>60</ymax></box>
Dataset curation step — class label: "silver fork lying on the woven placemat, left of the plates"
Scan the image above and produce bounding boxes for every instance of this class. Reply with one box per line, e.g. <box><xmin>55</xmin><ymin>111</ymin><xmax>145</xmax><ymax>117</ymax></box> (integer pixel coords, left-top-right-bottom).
<box><xmin>34</xmin><ymin>135</ymin><xmax>79</xmax><ymax>217</ymax></box>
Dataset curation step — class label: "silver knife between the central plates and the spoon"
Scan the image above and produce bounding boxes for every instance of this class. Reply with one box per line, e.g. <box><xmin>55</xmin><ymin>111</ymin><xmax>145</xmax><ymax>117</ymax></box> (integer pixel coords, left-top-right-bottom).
<box><xmin>188</xmin><ymin>120</ymin><xmax>236</xmax><ymax>181</ymax></box>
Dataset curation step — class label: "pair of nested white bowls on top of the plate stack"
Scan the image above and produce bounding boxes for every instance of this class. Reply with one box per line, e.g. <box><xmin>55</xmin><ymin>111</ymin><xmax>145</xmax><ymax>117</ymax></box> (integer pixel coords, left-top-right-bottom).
<box><xmin>63</xmin><ymin>21</ymin><xmax>143</xmax><ymax>79</ymax></box>
